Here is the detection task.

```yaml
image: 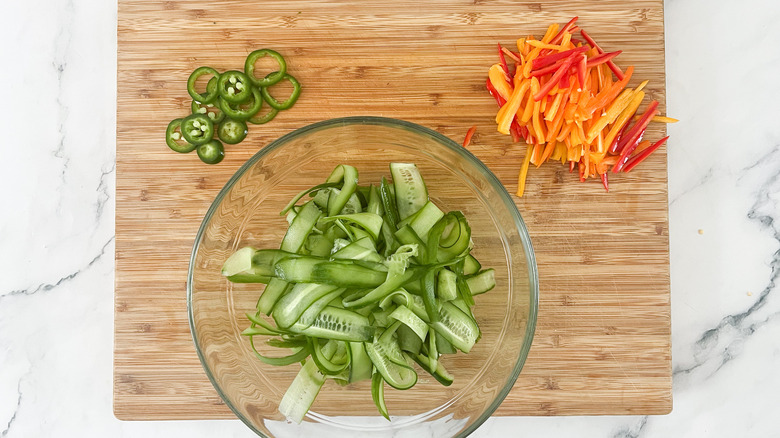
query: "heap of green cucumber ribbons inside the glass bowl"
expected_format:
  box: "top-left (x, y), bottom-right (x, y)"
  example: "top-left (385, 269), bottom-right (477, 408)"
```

top-left (225, 163), bottom-right (495, 422)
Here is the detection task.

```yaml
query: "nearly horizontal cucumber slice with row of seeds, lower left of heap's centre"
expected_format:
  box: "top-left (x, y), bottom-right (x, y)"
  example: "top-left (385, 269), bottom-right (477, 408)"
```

top-left (290, 306), bottom-right (375, 342)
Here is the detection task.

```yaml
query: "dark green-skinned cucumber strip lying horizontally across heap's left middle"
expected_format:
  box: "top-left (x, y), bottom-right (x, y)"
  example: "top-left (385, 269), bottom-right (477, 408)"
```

top-left (276, 257), bottom-right (387, 288)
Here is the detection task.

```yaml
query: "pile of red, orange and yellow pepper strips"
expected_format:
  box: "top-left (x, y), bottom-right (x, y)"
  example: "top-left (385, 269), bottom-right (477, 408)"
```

top-left (487, 17), bottom-right (677, 196)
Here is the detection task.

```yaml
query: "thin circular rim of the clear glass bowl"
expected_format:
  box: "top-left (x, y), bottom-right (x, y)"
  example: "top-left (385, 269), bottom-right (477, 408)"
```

top-left (187, 116), bottom-right (539, 438)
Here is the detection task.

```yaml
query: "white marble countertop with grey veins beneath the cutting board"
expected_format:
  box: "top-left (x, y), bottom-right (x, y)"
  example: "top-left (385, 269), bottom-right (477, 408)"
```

top-left (0, 0), bottom-right (780, 438)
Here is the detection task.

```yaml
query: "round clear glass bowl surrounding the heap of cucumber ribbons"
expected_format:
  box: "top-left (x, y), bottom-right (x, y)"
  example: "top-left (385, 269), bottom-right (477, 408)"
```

top-left (187, 117), bottom-right (538, 438)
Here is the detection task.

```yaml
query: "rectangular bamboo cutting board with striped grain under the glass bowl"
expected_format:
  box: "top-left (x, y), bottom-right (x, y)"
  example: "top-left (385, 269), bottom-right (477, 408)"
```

top-left (114, 0), bottom-right (674, 420)
